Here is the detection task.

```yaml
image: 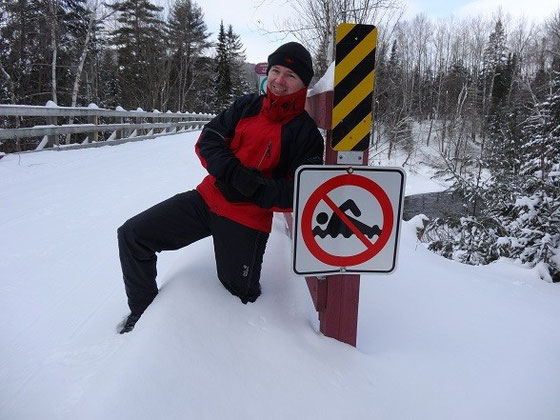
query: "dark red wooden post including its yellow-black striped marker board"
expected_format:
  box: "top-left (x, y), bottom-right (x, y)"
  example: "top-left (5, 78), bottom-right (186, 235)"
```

top-left (288, 24), bottom-right (377, 346)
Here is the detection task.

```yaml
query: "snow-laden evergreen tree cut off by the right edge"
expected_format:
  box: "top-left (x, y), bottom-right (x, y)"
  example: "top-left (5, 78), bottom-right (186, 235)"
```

top-left (505, 72), bottom-right (560, 281)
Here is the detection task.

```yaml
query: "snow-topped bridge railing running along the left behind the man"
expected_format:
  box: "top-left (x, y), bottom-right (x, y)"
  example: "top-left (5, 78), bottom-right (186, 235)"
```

top-left (0, 103), bottom-right (214, 152)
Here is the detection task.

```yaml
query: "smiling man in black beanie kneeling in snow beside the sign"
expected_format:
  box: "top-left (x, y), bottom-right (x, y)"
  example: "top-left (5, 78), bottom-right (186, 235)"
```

top-left (118, 42), bottom-right (323, 334)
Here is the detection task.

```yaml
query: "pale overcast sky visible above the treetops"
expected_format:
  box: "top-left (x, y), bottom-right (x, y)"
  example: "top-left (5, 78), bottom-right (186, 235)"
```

top-left (160, 0), bottom-right (560, 63)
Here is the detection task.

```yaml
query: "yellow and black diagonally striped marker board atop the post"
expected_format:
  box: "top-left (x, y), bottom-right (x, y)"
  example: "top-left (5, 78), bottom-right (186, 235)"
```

top-left (332, 23), bottom-right (377, 151)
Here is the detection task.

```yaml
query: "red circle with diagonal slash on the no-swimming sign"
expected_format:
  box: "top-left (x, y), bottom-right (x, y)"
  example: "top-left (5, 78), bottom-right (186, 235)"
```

top-left (301, 174), bottom-right (394, 267)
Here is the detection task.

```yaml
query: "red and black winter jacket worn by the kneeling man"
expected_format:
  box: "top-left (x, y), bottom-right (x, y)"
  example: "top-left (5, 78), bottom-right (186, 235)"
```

top-left (195, 89), bottom-right (323, 232)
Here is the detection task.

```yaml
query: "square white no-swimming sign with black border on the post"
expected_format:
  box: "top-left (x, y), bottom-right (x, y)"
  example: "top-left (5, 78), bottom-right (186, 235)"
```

top-left (293, 165), bottom-right (405, 275)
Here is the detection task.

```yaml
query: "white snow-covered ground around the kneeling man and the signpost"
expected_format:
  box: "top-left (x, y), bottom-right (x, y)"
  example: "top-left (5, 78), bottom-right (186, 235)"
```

top-left (0, 133), bottom-right (560, 420)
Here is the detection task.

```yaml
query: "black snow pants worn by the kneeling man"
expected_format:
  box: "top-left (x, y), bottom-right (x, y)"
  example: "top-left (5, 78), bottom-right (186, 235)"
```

top-left (117, 190), bottom-right (268, 315)
